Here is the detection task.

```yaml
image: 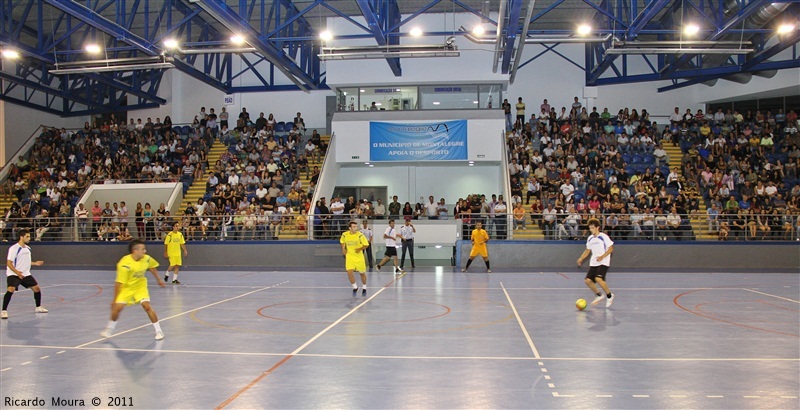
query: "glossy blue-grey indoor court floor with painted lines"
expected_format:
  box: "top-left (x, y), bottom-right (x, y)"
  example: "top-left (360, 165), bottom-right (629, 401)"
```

top-left (0, 263), bottom-right (800, 409)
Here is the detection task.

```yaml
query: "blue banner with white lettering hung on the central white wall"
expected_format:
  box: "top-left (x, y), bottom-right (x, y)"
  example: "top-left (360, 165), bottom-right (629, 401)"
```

top-left (369, 120), bottom-right (467, 161)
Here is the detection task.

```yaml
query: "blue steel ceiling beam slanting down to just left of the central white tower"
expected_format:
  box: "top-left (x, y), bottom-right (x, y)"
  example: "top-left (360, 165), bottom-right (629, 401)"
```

top-left (195, 0), bottom-right (319, 91)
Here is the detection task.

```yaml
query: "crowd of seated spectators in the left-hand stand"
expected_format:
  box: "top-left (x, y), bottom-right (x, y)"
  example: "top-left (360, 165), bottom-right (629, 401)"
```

top-left (0, 107), bottom-right (326, 240)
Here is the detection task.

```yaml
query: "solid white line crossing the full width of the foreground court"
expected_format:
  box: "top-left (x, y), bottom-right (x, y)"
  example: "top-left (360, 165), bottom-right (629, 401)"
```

top-left (0, 344), bottom-right (800, 360)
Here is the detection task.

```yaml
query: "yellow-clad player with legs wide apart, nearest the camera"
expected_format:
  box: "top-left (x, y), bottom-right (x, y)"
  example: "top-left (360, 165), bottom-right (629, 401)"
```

top-left (100, 239), bottom-right (167, 340)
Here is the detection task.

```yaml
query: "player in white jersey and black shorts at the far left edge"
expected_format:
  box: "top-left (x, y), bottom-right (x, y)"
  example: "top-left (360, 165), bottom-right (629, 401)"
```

top-left (0, 229), bottom-right (47, 319)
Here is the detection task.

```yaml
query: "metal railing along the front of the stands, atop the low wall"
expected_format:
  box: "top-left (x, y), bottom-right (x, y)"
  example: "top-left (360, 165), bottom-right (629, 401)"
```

top-left (0, 208), bottom-right (800, 242)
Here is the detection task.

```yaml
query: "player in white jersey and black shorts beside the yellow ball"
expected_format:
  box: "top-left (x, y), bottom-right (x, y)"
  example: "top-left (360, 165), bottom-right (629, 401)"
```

top-left (578, 218), bottom-right (614, 307)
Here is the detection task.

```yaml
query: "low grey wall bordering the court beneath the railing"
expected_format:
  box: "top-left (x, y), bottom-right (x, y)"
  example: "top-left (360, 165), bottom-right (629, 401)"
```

top-left (28, 241), bottom-right (800, 273)
